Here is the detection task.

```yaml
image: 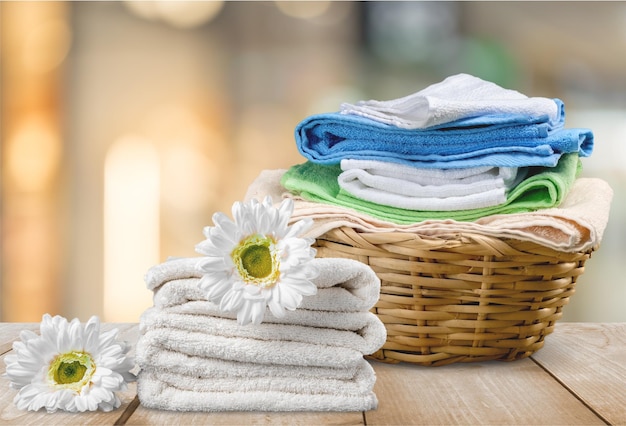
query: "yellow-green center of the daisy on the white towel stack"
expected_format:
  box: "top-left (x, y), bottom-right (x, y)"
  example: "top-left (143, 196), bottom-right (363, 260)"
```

top-left (231, 234), bottom-right (280, 288)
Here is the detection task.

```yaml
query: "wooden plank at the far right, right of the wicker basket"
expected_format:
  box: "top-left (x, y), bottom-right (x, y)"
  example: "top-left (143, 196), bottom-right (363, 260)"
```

top-left (532, 323), bottom-right (626, 425)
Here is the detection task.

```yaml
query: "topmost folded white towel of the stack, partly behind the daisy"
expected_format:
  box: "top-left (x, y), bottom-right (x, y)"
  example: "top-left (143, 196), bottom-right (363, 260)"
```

top-left (145, 258), bottom-right (380, 312)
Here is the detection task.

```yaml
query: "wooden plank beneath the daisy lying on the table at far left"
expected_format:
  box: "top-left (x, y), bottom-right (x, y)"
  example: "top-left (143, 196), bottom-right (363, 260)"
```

top-left (0, 323), bottom-right (138, 425)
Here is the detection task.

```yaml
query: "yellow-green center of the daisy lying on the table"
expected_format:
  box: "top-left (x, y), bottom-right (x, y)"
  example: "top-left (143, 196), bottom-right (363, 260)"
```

top-left (48, 352), bottom-right (96, 392)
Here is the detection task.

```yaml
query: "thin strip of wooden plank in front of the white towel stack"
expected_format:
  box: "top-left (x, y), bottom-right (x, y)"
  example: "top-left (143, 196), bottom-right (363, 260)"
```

top-left (126, 406), bottom-right (364, 426)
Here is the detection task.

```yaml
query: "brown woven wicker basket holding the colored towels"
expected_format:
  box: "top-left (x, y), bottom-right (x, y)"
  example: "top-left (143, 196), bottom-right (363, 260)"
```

top-left (314, 227), bottom-right (593, 366)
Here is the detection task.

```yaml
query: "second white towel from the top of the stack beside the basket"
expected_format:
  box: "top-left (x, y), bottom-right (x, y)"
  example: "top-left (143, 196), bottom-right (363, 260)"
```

top-left (139, 308), bottom-right (386, 355)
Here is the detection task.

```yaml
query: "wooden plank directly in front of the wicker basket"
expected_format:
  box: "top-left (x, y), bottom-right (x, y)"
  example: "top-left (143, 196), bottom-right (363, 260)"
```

top-left (365, 359), bottom-right (604, 425)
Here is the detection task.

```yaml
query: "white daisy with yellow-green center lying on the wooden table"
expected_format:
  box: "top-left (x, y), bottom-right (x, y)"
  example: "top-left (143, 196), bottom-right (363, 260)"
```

top-left (4, 314), bottom-right (135, 413)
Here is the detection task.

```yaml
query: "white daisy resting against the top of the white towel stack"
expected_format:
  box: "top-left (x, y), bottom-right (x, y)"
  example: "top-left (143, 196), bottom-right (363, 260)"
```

top-left (196, 197), bottom-right (317, 325)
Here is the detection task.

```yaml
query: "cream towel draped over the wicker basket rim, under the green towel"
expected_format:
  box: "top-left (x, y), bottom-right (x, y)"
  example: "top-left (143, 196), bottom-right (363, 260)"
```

top-left (245, 169), bottom-right (613, 253)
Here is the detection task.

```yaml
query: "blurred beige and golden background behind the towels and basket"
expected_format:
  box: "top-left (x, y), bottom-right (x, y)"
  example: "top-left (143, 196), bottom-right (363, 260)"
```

top-left (0, 1), bottom-right (626, 322)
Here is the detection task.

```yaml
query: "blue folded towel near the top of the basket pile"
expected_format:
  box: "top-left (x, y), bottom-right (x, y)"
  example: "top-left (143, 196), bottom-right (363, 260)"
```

top-left (295, 113), bottom-right (593, 169)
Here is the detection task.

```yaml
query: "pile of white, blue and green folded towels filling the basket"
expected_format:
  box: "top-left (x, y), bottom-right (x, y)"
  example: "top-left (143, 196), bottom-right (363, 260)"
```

top-left (282, 74), bottom-right (593, 224)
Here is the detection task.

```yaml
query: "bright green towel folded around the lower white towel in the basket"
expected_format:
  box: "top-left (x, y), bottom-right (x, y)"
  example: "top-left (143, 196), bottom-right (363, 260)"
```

top-left (281, 153), bottom-right (582, 224)
